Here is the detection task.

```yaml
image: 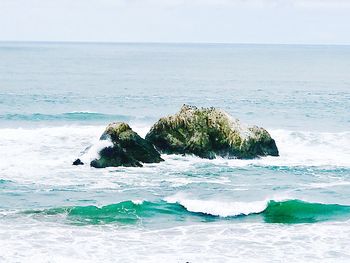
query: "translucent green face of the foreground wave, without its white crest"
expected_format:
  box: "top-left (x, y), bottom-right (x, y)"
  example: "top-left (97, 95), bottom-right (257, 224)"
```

top-left (24, 200), bottom-right (350, 225)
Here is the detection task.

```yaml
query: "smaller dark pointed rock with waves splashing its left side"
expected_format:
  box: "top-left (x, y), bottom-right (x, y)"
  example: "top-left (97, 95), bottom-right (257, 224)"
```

top-left (90, 122), bottom-right (163, 168)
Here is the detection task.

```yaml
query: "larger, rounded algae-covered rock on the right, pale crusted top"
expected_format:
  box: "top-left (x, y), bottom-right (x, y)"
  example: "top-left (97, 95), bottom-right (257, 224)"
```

top-left (146, 105), bottom-right (278, 159)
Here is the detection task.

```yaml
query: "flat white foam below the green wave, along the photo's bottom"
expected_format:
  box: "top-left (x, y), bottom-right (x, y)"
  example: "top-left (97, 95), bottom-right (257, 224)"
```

top-left (0, 218), bottom-right (350, 263)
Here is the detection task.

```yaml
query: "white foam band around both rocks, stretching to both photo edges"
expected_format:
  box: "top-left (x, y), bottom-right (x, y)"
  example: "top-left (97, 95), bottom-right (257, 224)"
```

top-left (0, 124), bottom-right (350, 188)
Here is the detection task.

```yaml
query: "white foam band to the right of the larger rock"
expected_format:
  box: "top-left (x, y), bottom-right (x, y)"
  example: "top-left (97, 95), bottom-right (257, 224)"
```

top-left (202, 130), bottom-right (350, 167)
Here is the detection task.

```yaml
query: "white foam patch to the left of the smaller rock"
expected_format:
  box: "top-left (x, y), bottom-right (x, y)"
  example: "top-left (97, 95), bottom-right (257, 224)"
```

top-left (0, 126), bottom-right (104, 184)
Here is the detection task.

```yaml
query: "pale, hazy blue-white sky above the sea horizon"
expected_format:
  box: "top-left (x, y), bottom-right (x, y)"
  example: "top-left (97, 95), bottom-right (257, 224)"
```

top-left (0, 0), bottom-right (350, 44)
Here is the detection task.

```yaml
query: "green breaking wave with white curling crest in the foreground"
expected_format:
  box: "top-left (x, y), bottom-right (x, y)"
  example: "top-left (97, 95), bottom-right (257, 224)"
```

top-left (22, 199), bottom-right (350, 225)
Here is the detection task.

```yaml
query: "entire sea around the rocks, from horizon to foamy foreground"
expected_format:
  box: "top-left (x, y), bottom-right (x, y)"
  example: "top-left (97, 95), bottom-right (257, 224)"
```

top-left (0, 42), bottom-right (350, 262)
